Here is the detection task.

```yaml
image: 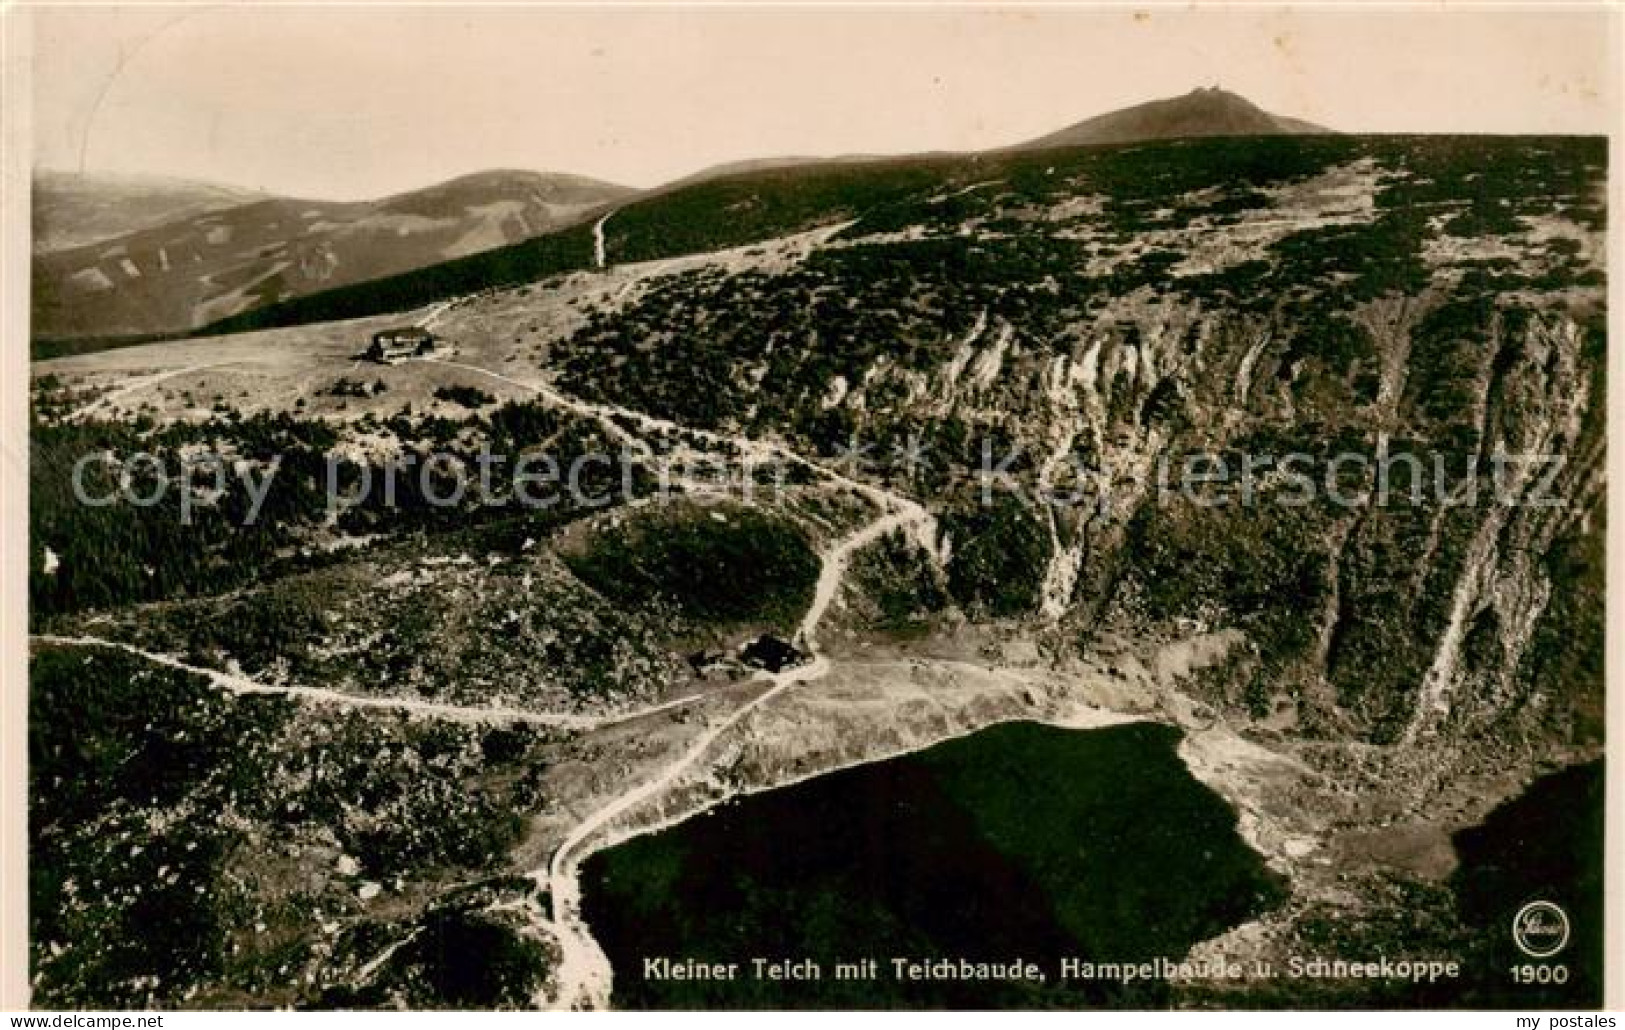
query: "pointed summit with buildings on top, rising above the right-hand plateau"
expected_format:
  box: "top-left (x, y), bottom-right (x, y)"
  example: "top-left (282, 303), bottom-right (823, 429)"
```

top-left (1011, 88), bottom-right (1331, 149)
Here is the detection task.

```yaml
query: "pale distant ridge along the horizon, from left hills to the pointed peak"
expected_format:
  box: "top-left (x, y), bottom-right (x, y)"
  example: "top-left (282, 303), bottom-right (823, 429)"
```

top-left (34, 88), bottom-right (1329, 341)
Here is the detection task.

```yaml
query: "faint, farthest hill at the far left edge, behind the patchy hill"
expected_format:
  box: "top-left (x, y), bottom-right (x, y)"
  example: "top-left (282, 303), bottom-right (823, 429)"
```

top-left (33, 169), bottom-right (260, 253)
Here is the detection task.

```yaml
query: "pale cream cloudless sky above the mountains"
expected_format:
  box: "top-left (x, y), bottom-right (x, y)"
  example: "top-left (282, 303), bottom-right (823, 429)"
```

top-left (28, 3), bottom-right (1619, 200)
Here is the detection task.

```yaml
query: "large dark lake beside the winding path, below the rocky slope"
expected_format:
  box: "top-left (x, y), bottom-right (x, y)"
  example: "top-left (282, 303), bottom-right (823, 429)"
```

top-left (582, 723), bottom-right (1282, 1009)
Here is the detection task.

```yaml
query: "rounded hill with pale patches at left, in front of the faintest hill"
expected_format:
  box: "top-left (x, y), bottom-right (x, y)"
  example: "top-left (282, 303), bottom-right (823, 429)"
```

top-left (34, 171), bottom-right (632, 340)
